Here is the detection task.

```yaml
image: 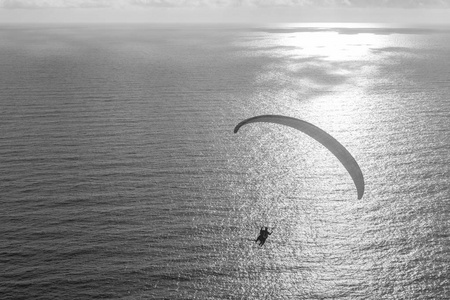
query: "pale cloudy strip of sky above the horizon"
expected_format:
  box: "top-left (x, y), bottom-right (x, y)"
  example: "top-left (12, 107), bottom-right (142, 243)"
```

top-left (0, 0), bottom-right (450, 24)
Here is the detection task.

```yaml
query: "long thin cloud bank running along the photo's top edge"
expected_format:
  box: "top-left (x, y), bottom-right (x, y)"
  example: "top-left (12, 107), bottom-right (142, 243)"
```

top-left (0, 0), bottom-right (450, 9)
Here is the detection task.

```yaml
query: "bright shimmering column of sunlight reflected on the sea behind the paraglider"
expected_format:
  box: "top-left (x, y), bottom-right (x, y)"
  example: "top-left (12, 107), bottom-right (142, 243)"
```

top-left (232, 26), bottom-right (436, 298)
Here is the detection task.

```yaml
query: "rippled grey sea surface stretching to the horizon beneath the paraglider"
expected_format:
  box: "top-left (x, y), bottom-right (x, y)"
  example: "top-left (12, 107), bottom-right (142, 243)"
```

top-left (0, 24), bottom-right (450, 300)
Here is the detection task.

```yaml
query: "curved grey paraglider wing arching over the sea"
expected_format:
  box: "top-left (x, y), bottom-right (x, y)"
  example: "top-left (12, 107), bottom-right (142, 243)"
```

top-left (234, 115), bottom-right (364, 199)
